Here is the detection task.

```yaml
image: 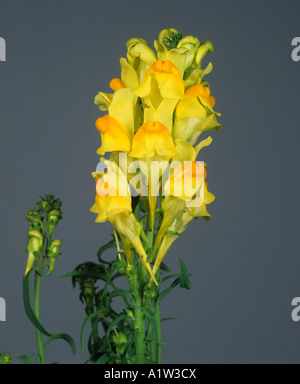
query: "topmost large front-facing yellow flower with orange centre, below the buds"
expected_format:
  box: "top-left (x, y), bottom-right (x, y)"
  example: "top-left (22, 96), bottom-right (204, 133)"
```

top-left (134, 60), bottom-right (184, 132)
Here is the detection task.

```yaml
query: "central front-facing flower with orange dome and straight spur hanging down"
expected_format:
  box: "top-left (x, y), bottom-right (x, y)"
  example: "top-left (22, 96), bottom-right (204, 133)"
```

top-left (129, 121), bottom-right (177, 228)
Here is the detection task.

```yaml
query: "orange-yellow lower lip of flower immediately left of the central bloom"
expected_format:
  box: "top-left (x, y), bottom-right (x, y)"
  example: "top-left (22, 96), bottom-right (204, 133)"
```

top-left (96, 116), bottom-right (131, 155)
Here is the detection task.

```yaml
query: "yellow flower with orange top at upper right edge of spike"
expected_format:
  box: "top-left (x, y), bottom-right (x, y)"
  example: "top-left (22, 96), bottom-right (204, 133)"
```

top-left (172, 84), bottom-right (222, 145)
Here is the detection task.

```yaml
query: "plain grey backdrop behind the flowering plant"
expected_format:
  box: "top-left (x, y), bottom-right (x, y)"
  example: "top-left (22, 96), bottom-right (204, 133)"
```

top-left (0, 0), bottom-right (300, 364)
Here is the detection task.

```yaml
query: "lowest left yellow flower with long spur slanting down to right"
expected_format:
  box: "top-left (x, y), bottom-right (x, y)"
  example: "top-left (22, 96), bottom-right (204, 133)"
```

top-left (91, 160), bottom-right (156, 282)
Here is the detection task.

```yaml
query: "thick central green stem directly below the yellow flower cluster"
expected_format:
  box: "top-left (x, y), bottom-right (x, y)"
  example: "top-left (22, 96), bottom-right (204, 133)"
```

top-left (134, 261), bottom-right (146, 364)
